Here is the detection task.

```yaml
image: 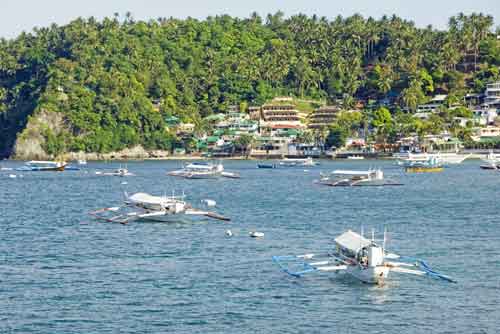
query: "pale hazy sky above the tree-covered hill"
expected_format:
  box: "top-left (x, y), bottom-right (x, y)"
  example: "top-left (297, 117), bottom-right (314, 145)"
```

top-left (0, 0), bottom-right (500, 38)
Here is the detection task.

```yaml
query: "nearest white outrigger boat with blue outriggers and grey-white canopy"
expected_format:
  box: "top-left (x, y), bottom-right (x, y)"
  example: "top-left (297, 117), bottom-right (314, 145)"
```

top-left (273, 230), bottom-right (456, 284)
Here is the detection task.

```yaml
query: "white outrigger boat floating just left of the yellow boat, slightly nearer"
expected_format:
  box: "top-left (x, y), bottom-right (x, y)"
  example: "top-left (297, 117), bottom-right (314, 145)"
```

top-left (319, 169), bottom-right (388, 187)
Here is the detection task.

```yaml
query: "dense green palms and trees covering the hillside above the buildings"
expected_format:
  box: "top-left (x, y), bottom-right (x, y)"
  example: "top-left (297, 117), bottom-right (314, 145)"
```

top-left (0, 12), bottom-right (500, 153)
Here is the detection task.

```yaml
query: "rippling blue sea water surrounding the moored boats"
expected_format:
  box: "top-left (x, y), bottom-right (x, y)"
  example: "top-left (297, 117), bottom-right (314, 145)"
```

top-left (0, 161), bottom-right (500, 334)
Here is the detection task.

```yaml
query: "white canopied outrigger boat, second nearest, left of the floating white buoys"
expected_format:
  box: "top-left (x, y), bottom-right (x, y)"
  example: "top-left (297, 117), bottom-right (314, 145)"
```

top-left (89, 193), bottom-right (230, 224)
